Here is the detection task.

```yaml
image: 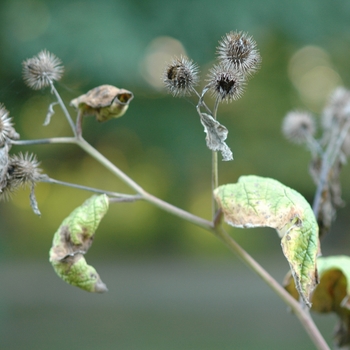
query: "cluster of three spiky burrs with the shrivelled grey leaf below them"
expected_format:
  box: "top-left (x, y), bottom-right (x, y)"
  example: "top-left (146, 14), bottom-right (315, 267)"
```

top-left (163, 32), bottom-right (261, 160)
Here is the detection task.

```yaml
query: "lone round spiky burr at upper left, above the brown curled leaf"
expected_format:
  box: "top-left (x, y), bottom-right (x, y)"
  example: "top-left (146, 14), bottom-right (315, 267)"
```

top-left (22, 50), bottom-right (64, 90)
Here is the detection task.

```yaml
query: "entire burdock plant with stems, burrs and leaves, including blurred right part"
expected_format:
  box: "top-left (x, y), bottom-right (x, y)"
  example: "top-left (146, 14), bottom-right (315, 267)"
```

top-left (0, 32), bottom-right (350, 349)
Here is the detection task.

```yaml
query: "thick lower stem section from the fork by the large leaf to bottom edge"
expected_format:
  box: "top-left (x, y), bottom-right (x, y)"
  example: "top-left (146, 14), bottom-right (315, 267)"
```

top-left (213, 227), bottom-right (330, 350)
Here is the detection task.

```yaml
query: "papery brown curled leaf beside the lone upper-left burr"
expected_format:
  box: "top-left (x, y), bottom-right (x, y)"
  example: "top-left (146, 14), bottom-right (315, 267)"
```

top-left (70, 85), bottom-right (134, 122)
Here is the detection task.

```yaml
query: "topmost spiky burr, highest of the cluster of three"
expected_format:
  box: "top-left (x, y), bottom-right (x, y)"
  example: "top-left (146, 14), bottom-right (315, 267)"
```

top-left (216, 32), bottom-right (261, 76)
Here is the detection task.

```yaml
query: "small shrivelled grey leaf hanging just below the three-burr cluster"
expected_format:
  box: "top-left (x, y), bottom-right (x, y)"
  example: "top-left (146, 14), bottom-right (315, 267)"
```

top-left (199, 113), bottom-right (233, 160)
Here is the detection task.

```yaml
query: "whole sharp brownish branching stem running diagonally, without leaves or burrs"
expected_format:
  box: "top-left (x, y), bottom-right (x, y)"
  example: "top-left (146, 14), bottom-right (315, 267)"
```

top-left (12, 84), bottom-right (328, 350)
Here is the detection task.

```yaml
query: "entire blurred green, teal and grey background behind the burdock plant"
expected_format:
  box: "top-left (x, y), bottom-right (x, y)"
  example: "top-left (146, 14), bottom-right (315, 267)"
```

top-left (0, 0), bottom-right (350, 350)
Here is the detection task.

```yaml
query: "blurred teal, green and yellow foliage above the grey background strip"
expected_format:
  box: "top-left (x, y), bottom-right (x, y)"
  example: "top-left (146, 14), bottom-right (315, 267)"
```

top-left (0, 0), bottom-right (350, 256)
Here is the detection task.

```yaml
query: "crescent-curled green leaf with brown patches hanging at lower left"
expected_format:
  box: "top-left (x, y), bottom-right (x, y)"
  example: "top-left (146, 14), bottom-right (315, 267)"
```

top-left (50, 194), bottom-right (109, 293)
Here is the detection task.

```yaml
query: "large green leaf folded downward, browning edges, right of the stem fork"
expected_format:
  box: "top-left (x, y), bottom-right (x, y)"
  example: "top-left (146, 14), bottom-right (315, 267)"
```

top-left (214, 175), bottom-right (319, 307)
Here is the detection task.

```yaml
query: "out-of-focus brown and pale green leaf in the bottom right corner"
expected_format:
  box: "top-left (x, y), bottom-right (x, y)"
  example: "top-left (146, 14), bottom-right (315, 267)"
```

top-left (283, 255), bottom-right (350, 349)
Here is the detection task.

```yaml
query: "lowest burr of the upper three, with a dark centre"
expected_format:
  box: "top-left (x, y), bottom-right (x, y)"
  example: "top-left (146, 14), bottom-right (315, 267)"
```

top-left (207, 64), bottom-right (245, 102)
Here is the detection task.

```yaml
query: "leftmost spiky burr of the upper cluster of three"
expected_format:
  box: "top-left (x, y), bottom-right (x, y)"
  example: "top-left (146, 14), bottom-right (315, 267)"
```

top-left (163, 56), bottom-right (199, 96)
